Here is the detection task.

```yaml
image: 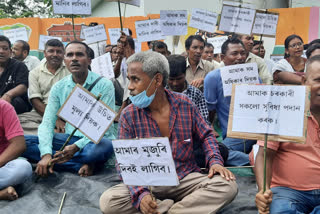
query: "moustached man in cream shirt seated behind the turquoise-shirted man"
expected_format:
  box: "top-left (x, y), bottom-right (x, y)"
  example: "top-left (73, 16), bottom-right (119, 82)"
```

top-left (19, 39), bottom-right (70, 135)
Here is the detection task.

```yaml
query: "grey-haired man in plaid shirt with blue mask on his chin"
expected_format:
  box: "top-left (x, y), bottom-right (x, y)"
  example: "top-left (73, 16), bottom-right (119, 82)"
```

top-left (100, 52), bottom-right (237, 214)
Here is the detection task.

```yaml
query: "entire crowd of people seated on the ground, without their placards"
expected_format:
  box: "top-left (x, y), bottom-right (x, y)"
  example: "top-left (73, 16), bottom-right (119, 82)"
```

top-left (0, 33), bottom-right (320, 213)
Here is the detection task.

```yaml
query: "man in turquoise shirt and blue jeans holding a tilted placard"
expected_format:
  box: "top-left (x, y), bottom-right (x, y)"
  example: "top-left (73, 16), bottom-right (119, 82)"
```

top-left (23, 41), bottom-right (115, 176)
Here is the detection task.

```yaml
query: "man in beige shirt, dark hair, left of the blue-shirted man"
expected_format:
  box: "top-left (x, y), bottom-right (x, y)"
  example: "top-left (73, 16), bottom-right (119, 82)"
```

top-left (185, 35), bottom-right (216, 89)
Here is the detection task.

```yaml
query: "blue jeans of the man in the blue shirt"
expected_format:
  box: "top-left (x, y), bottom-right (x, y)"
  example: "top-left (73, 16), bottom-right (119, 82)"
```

top-left (222, 137), bottom-right (257, 166)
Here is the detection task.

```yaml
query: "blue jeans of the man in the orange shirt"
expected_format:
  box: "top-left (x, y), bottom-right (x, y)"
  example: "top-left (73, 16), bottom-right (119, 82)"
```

top-left (270, 187), bottom-right (320, 214)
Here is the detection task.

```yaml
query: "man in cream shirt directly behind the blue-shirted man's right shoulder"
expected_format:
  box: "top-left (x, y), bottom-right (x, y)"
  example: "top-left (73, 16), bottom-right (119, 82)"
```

top-left (232, 34), bottom-right (272, 85)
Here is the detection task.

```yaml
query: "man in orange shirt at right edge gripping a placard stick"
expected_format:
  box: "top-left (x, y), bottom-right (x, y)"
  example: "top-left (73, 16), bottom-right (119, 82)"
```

top-left (255, 55), bottom-right (320, 214)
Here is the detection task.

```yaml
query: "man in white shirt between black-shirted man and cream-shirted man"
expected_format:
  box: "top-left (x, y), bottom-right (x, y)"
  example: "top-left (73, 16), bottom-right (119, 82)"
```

top-left (12, 40), bottom-right (40, 71)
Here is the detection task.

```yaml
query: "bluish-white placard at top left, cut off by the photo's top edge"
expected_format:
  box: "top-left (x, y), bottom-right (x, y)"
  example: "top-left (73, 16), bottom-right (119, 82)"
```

top-left (52, 0), bottom-right (91, 15)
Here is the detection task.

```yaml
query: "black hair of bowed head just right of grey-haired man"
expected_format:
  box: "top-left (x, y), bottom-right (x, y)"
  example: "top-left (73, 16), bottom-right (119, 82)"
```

top-left (167, 54), bottom-right (187, 77)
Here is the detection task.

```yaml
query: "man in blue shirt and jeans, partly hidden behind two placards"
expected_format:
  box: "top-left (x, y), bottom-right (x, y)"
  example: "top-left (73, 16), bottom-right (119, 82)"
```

top-left (204, 38), bottom-right (255, 166)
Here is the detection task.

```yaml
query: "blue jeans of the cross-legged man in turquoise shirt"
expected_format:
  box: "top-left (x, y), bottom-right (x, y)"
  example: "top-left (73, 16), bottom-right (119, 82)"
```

top-left (22, 133), bottom-right (113, 172)
